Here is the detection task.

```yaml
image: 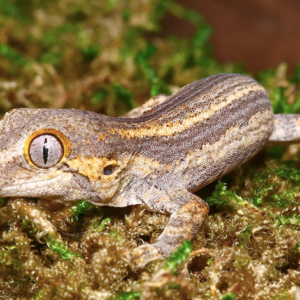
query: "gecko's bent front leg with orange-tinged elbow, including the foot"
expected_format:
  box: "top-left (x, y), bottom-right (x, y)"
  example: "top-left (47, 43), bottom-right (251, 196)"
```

top-left (131, 189), bottom-right (209, 269)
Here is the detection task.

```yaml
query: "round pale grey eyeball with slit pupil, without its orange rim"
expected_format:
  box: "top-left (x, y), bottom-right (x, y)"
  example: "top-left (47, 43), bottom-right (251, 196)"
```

top-left (29, 134), bottom-right (64, 169)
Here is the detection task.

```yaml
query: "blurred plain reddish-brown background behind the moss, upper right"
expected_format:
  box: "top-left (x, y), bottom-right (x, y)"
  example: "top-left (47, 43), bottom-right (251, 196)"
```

top-left (162, 0), bottom-right (300, 73)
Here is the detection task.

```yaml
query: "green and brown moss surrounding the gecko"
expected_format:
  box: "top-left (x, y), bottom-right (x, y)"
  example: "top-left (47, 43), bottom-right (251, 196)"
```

top-left (0, 0), bottom-right (300, 300)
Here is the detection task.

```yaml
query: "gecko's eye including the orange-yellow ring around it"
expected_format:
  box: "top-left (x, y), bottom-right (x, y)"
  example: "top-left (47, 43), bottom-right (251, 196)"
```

top-left (24, 129), bottom-right (71, 169)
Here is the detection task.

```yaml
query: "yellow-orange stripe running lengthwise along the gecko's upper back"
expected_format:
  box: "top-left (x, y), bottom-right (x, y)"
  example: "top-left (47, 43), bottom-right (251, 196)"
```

top-left (108, 77), bottom-right (265, 140)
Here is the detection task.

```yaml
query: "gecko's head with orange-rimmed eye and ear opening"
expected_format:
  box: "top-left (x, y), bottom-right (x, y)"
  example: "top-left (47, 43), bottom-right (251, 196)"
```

top-left (0, 109), bottom-right (130, 205)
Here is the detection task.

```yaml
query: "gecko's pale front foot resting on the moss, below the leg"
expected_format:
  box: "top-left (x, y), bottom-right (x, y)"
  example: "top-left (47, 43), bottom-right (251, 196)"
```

top-left (130, 244), bottom-right (162, 270)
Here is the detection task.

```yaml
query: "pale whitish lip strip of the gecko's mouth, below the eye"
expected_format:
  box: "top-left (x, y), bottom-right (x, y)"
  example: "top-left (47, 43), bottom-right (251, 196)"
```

top-left (0, 173), bottom-right (72, 197)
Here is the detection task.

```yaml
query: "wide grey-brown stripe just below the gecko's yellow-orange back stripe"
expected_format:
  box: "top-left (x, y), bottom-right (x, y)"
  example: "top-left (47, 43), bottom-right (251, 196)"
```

top-left (135, 88), bottom-right (271, 164)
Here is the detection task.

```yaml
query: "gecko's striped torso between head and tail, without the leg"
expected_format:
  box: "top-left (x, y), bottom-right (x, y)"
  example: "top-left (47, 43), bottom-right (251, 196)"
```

top-left (116, 74), bottom-right (274, 191)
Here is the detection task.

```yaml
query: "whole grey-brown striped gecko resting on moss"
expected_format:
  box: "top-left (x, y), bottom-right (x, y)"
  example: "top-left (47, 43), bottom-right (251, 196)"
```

top-left (0, 74), bottom-right (300, 269)
